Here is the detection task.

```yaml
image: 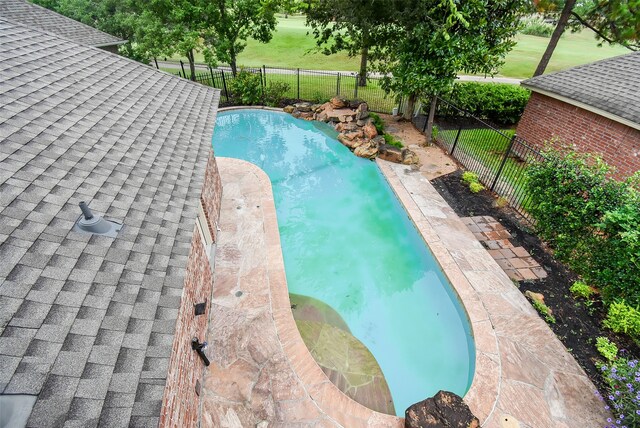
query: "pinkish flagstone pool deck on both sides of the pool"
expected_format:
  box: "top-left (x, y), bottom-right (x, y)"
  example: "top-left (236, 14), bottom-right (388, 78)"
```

top-left (200, 158), bottom-right (607, 428)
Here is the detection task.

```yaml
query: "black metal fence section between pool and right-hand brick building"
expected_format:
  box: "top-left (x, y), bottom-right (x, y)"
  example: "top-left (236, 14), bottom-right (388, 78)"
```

top-left (414, 98), bottom-right (543, 221)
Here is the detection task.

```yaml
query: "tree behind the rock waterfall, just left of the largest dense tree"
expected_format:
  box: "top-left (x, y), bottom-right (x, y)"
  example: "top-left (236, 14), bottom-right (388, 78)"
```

top-left (307, 0), bottom-right (391, 86)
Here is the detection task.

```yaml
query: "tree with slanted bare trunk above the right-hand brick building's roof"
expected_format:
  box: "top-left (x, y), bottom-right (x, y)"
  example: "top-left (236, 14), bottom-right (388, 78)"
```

top-left (533, 0), bottom-right (640, 76)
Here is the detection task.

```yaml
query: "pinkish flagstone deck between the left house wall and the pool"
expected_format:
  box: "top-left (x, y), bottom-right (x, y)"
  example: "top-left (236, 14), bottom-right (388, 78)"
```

top-left (201, 158), bottom-right (404, 428)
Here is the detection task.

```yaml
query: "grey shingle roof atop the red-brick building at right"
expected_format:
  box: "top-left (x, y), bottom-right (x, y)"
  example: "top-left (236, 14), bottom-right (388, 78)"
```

top-left (522, 52), bottom-right (640, 124)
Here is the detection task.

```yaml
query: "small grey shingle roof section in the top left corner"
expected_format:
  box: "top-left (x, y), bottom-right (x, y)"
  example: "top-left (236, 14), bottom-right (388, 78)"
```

top-left (0, 0), bottom-right (124, 47)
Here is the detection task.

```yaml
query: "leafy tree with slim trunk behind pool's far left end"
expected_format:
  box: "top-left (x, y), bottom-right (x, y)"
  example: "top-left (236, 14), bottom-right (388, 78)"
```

top-left (203, 0), bottom-right (278, 76)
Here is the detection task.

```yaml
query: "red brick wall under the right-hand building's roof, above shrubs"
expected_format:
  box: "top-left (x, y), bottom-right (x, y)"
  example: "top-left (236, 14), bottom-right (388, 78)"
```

top-left (517, 92), bottom-right (640, 179)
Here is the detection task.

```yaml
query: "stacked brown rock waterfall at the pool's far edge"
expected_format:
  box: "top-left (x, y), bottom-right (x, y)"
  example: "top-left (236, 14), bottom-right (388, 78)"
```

top-left (284, 97), bottom-right (418, 165)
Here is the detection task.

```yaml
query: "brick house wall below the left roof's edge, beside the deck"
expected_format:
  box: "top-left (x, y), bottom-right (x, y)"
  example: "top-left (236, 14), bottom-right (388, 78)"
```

top-left (159, 153), bottom-right (222, 427)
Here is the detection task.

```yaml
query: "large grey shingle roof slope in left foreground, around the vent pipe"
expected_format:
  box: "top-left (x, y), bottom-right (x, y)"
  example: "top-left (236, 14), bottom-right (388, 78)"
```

top-left (0, 18), bottom-right (218, 427)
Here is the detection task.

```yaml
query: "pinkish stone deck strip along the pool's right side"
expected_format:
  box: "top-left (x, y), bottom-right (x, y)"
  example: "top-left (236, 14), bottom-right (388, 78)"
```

top-left (376, 159), bottom-right (609, 428)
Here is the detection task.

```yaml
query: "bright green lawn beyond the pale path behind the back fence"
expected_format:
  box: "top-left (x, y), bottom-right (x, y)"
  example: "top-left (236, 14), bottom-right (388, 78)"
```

top-left (175, 16), bottom-right (629, 78)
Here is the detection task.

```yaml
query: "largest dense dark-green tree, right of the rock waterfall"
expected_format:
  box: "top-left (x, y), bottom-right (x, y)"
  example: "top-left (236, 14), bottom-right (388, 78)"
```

top-left (377, 0), bottom-right (526, 120)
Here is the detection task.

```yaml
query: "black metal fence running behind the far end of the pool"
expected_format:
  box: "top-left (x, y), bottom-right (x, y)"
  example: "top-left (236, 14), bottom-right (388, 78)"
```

top-left (165, 61), bottom-right (398, 113)
